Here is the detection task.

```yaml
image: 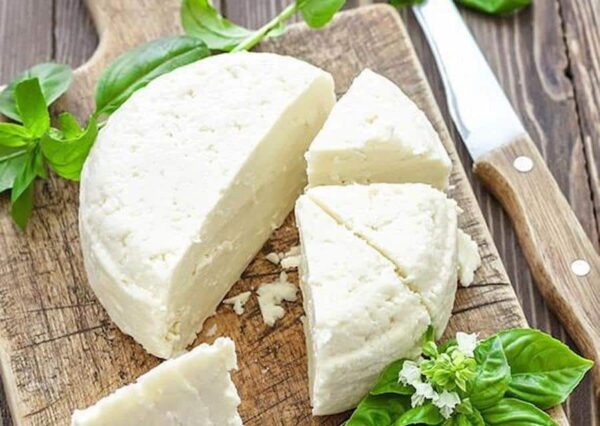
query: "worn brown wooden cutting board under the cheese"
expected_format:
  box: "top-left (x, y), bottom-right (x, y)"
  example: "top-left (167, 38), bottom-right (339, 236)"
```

top-left (0, 0), bottom-right (567, 425)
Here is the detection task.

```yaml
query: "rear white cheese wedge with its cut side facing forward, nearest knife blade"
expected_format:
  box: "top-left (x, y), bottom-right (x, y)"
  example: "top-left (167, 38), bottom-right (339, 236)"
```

top-left (306, 69), bottom-right (451, 189)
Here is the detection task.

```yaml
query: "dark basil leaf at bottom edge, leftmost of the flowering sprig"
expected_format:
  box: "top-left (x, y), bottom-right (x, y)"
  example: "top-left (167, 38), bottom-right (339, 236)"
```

top-left (345, 395), bottom-right (410, 426)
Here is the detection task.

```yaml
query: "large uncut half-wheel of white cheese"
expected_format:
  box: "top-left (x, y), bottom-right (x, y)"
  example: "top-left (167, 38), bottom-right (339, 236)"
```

top-left (79, 52), bottom-right (335, 358)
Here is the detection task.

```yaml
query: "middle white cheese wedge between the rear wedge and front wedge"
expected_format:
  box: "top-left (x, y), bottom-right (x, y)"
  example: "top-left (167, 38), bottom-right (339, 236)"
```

top-left (307, 184), bottom-right (458, 337)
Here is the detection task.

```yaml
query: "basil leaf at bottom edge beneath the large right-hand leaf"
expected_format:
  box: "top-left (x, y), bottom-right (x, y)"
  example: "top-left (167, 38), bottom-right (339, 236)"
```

top-left (481, 398), bottom-right (556, 426)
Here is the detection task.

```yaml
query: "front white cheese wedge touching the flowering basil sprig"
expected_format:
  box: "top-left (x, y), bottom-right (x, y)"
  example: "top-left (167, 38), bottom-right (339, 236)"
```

top-left (295, 195), bottom-right (430, 415)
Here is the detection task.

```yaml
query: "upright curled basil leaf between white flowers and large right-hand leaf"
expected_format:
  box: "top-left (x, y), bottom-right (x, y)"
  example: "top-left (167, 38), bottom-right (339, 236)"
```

top-left (469, 337), bottom-right (511, 409)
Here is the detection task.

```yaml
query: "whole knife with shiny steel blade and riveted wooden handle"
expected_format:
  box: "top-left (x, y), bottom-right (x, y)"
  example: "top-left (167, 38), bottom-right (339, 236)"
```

top-left (413, 0), bottom-right (600, 400)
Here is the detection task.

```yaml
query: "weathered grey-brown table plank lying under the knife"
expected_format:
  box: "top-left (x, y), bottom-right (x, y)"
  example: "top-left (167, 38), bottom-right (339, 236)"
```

top-left (396, 2), bottom-right (598, 424)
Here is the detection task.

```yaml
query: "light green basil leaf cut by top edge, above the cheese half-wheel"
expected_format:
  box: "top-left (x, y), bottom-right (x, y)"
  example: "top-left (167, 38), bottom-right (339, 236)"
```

top-left (181, 0), bottom-right (253, 51)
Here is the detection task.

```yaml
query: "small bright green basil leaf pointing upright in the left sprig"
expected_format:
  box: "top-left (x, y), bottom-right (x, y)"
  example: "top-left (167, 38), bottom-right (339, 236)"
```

top-left (15, 78), bottom-right (50, 138)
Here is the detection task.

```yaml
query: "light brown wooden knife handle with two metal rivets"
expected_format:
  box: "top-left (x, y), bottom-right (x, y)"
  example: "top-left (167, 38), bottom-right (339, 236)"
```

top-left (475, 136), bottom-right (600, 400)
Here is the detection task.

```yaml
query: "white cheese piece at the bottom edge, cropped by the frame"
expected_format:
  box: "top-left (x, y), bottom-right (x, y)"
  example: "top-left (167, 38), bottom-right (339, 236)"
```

top-left (71, 338), bottom-right (242, 426)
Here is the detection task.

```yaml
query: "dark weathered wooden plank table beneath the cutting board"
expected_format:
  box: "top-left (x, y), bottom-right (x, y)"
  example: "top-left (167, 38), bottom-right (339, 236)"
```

top-left (0, 0), bottom-right (600, 425)
